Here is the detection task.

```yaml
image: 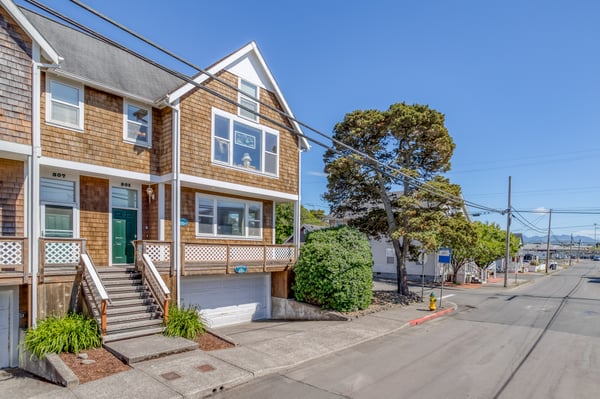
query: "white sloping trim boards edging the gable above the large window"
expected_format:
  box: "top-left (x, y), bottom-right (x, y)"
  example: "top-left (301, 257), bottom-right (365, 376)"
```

top-left (167, 42), bottom-right (310, 150)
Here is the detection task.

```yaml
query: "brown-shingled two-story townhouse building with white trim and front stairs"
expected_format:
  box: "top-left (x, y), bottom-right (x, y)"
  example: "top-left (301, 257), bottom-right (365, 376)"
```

top-left (0, 0), bottom-right (308, 368)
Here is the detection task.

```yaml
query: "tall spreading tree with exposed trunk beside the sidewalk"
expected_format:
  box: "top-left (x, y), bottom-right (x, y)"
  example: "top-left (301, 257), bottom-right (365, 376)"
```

top-left (323, 103), bottom-right (454, 295)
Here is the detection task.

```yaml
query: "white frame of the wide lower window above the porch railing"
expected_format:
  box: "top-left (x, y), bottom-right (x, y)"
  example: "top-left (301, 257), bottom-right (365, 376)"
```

top-left (195, 193), bottom-right (264, 240)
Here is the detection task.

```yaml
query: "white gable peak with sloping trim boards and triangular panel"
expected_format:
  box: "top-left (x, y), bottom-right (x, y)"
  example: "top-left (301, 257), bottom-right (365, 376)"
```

top-left (167, 41), bottom-right (310, 149)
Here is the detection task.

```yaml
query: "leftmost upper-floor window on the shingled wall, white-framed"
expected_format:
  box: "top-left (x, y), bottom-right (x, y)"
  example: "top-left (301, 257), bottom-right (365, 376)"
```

top-left (46, 78), bottom-right (83, 130)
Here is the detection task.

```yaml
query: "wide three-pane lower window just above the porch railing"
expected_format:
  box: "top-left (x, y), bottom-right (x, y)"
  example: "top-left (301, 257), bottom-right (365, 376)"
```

top-left (196, 194), bottom-right (262, 238)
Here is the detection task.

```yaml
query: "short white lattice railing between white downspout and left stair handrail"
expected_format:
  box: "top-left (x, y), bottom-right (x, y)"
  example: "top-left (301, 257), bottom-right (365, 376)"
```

top-left (40, 238), bottom-right (85, 276)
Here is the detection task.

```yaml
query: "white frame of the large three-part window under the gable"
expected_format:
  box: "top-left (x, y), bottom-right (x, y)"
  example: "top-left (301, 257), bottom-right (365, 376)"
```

top-left (210, 108), bottom-right (281, 177)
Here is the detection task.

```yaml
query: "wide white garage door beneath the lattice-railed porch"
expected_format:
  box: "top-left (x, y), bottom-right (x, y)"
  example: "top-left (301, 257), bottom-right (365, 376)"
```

top-left (181, 273), bottom-right (271, 327)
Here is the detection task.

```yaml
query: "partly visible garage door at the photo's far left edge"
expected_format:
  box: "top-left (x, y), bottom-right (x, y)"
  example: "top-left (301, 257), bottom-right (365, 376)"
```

top-left (0, 289), bottom-right (19, 368)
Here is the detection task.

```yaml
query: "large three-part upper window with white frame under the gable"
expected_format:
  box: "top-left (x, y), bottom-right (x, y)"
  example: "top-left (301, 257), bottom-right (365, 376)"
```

top-left (212, 109), bottom-right (279, 176)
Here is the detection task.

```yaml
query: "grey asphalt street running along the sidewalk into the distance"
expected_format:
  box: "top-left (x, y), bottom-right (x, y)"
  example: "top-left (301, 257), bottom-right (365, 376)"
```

top-left (215, 261), bottom-right (600, 399)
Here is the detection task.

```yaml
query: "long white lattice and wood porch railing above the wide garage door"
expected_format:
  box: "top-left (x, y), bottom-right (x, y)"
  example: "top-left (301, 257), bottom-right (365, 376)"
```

top-left (182, 243), bottom-right (297, 274)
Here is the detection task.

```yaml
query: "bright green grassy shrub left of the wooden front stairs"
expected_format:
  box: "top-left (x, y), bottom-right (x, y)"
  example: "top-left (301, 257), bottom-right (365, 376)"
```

top-left (24, 313), bottom-right (102, 359)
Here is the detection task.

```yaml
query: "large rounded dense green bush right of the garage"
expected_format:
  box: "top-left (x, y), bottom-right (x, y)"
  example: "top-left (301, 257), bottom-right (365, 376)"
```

top-left (293, 226), bottom-right (373, 312)
